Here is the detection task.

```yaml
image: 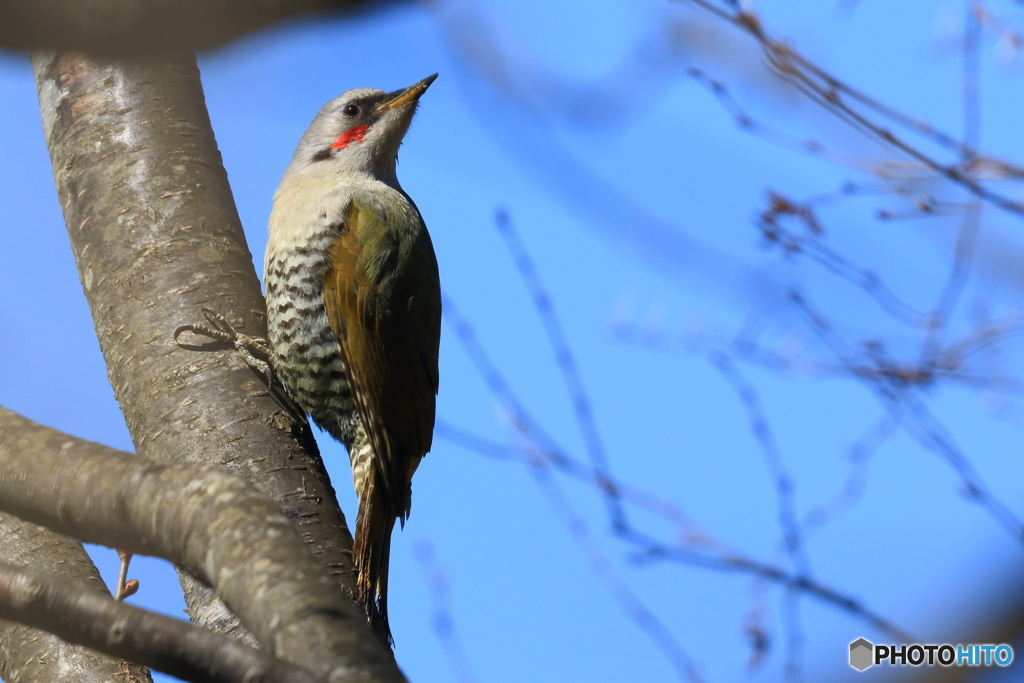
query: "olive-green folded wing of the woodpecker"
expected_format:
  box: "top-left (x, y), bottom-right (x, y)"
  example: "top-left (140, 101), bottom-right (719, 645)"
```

top-left (324, 198), bottom-right (440, 511)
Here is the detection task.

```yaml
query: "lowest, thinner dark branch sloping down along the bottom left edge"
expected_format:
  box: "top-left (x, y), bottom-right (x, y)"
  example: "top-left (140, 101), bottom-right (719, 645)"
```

top-left (0, 562), bottom-right (324, 683)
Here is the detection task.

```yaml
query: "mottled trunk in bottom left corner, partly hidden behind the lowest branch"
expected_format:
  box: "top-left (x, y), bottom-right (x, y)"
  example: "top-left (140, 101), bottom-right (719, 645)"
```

top-left (0, 513), bottom-right (152, 683)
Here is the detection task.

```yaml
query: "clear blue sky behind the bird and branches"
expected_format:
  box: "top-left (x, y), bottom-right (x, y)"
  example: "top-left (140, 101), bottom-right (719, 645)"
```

top-left (0, 0), bottom-right (1024, 683)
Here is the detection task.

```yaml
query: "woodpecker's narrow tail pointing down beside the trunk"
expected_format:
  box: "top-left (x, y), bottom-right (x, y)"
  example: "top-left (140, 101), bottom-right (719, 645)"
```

top-left (351, 430), bottom-right (398, 646)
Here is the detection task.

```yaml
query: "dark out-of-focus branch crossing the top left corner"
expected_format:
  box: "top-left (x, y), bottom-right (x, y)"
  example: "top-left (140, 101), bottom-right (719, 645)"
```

top-left (0, 0), bottom-right (398, 55)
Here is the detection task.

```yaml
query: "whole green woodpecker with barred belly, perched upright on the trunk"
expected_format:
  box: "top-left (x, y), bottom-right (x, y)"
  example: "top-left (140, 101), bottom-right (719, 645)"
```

top-left (264, 74), bottom-right (441, 643)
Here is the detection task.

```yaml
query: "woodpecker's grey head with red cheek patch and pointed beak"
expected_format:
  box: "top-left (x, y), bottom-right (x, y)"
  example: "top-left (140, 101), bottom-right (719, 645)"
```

top-left (291, 74), bottom-right (437, 185)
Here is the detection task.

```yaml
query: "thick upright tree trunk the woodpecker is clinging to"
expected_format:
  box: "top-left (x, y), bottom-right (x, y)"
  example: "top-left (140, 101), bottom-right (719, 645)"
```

top-left (33, 53), bottom-right (354, 638)
